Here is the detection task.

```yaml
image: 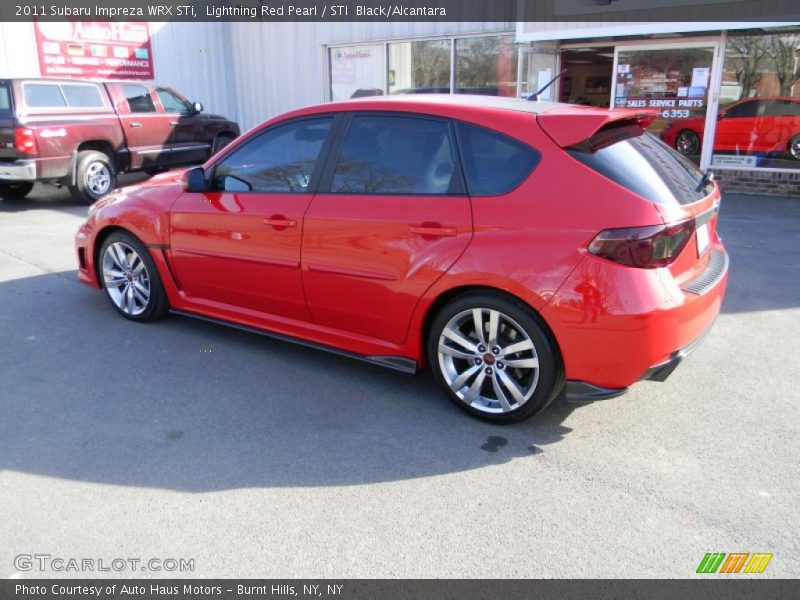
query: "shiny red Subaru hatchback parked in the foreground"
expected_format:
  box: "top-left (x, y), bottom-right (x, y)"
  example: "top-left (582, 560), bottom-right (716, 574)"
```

top-left (76, 95), bottom-right (728, 421)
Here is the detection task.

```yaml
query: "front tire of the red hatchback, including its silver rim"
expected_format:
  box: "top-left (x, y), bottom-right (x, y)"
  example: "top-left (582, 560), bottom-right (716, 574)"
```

top-left (97, 231), bottom-right (169, 321)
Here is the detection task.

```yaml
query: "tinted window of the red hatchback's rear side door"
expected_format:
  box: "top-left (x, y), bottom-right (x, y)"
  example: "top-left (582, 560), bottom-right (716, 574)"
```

top-left (331, 115), bottom-right (463, 195)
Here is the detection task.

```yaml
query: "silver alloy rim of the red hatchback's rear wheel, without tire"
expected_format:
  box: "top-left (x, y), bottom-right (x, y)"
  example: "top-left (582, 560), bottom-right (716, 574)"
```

top-left (438, 308), bottom-right (539, 414)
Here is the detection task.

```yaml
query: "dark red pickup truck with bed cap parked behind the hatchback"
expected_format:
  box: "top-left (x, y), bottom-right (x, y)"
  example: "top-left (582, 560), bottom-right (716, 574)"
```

top-left (0, 79), bottom-right (239, 203)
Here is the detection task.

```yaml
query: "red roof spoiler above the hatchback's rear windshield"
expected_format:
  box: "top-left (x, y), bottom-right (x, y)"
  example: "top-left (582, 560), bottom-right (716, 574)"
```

top-left (536, 106), bottom-right (658, 148)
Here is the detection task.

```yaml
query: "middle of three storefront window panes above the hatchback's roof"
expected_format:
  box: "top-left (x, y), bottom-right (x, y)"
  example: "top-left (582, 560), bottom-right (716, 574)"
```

top-left (388, 40), bottom-right (450, 94)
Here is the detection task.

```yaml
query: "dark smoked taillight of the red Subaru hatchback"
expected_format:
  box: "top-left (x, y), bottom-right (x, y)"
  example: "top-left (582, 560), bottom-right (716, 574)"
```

top-left (589, 219), bottom-right (694, 269)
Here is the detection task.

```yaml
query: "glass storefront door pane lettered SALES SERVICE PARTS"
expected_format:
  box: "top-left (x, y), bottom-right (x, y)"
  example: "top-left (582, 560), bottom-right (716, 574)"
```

top-left (611, 46), bottom-right (714, 164)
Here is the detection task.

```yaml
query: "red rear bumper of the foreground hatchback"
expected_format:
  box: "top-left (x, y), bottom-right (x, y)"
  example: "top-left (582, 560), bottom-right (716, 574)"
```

top-left (541, 242), bottom-right (728, 392)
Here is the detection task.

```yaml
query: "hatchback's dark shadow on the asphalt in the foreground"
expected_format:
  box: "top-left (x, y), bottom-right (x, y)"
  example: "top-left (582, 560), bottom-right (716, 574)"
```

top-left (0, 273), bottom-right (575, 492)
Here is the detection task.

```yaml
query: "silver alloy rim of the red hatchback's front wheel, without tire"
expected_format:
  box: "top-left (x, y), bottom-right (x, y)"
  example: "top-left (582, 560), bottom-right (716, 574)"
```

top-left (103, 242), bottom-right (151, 316)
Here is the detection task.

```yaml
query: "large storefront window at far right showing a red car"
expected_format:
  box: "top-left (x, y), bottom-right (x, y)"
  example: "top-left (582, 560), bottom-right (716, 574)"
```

top-left (711, 33), bottom-right (800, 169)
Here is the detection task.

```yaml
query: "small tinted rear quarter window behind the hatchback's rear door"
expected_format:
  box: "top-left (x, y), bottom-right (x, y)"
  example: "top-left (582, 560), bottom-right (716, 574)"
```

top-left (456, 122), bottom-right (540, 196)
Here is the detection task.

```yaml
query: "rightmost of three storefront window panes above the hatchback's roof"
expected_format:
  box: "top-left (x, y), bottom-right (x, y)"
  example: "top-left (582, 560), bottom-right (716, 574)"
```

top-left (454, 35), bottom-right (519, 97)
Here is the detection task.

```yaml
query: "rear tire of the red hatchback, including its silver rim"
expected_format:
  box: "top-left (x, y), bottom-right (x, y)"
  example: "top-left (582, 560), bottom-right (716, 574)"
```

top-left (426, 292), bottom-right (564, 423)
